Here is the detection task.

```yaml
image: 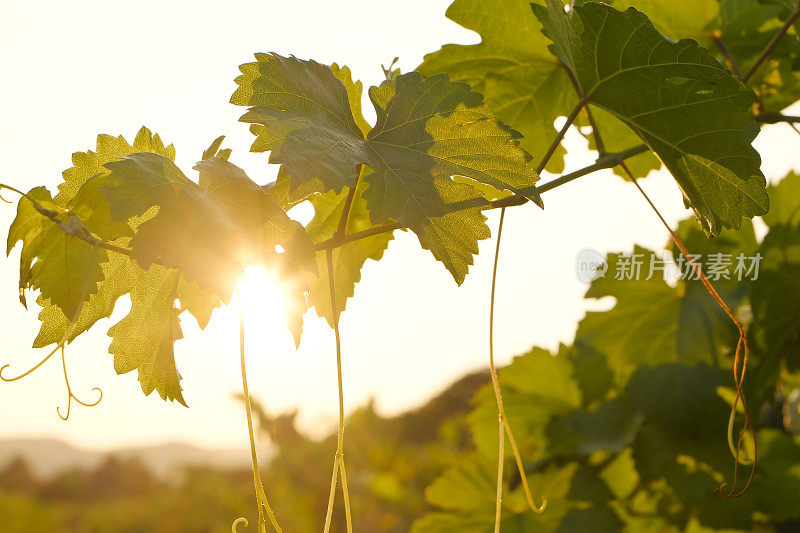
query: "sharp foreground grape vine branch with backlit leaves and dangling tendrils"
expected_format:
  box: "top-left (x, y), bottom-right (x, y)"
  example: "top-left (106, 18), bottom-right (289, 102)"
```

top-left (0, 0), bottom-right (800, 533)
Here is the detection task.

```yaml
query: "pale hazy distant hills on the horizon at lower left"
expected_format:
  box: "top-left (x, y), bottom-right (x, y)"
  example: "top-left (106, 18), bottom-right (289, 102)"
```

top-left (0, 438), bottom-right (255, 479)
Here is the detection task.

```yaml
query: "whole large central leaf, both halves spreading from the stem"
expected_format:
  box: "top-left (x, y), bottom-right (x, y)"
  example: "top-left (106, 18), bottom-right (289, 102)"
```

top-left (231, 54), bottom-right (540, 283)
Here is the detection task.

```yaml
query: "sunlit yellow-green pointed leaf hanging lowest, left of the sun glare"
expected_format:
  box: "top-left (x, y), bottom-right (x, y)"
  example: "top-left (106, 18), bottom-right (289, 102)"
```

top-left (108, 265), bottom-right (186, 406)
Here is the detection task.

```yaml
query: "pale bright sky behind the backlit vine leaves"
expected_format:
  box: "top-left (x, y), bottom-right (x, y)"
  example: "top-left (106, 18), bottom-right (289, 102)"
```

top-left (0, 0), bottom-right (800, 448)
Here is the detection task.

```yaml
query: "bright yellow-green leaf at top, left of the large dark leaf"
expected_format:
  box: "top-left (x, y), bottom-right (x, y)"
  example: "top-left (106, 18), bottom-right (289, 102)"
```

top-left (418, 0), bottom-right (576, 172)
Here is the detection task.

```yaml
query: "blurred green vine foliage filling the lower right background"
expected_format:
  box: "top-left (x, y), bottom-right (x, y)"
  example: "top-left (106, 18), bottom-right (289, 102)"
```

top-left (413, 174), bottom-right (800, 533)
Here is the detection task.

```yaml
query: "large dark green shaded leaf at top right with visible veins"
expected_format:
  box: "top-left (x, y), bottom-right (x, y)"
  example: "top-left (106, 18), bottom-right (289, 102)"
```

top-left (533, 0), bottom-right (769, 235)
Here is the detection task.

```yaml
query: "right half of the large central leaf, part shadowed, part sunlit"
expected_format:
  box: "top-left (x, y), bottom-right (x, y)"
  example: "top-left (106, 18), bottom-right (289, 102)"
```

top-left (364, 72), bottom-right (541, 284)
